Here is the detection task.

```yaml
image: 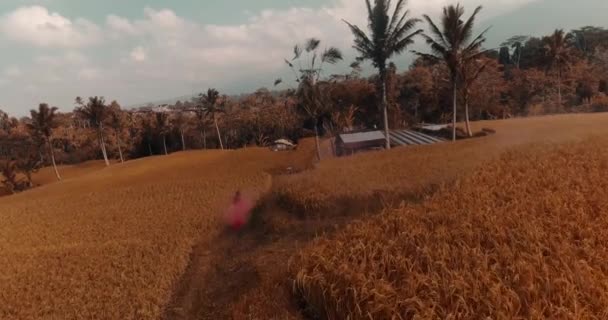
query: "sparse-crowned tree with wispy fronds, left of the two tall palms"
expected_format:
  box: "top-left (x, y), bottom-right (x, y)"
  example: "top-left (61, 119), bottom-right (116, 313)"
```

top-left (275, 38), bottom-right (343, 160)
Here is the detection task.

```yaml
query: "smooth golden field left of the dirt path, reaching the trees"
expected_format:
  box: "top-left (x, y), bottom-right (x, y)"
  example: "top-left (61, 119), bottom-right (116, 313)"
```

top-left (0, 142), bottom-right (320, 319)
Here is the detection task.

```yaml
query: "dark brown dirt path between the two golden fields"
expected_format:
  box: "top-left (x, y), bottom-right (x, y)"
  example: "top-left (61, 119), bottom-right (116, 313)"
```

top-left (163, 201), bottom-right (346, 320)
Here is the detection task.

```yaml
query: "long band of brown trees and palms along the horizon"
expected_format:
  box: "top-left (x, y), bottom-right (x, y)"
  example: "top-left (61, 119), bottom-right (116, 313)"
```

top-left (0, 0), bottom-right (608, 192)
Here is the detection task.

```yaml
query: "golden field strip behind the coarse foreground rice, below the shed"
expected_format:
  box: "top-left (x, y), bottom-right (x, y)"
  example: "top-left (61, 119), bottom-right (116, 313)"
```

top-left (276, 114), bottom-right (608, 215)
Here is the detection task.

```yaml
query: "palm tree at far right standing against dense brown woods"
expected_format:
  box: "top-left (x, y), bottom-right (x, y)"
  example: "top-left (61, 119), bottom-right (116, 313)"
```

top-left (543, 30), bottom-right (572, 107)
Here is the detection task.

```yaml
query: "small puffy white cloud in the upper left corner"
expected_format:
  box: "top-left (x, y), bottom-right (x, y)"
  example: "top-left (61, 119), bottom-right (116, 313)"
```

top-left (0, 6), bottom-right (101, 48)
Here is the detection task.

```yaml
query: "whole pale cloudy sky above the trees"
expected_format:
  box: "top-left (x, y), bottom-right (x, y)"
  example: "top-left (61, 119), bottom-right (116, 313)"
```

top-left (0, 0), bottom-right (608, 116)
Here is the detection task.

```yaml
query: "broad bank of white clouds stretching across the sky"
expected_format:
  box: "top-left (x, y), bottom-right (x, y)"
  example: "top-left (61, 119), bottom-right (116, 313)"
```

top-left (0, 0), bottom-right (535, 114)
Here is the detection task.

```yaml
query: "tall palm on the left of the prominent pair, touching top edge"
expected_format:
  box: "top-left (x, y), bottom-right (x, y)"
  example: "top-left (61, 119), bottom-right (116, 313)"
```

top-left (345, 0), bottom-right (422, 149)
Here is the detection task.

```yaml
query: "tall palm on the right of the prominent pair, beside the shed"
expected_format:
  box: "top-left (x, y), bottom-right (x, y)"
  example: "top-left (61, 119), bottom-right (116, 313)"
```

top-left (416, 4), bottom-right (488, 141)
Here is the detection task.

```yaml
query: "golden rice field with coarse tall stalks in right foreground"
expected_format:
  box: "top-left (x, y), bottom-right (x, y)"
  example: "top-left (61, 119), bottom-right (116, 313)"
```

top-left (292, 137), bottom-right (608, 319)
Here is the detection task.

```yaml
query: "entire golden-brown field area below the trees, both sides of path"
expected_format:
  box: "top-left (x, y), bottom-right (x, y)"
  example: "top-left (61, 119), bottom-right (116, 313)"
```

top-left (0, 114), bottom-right (608, 319)
